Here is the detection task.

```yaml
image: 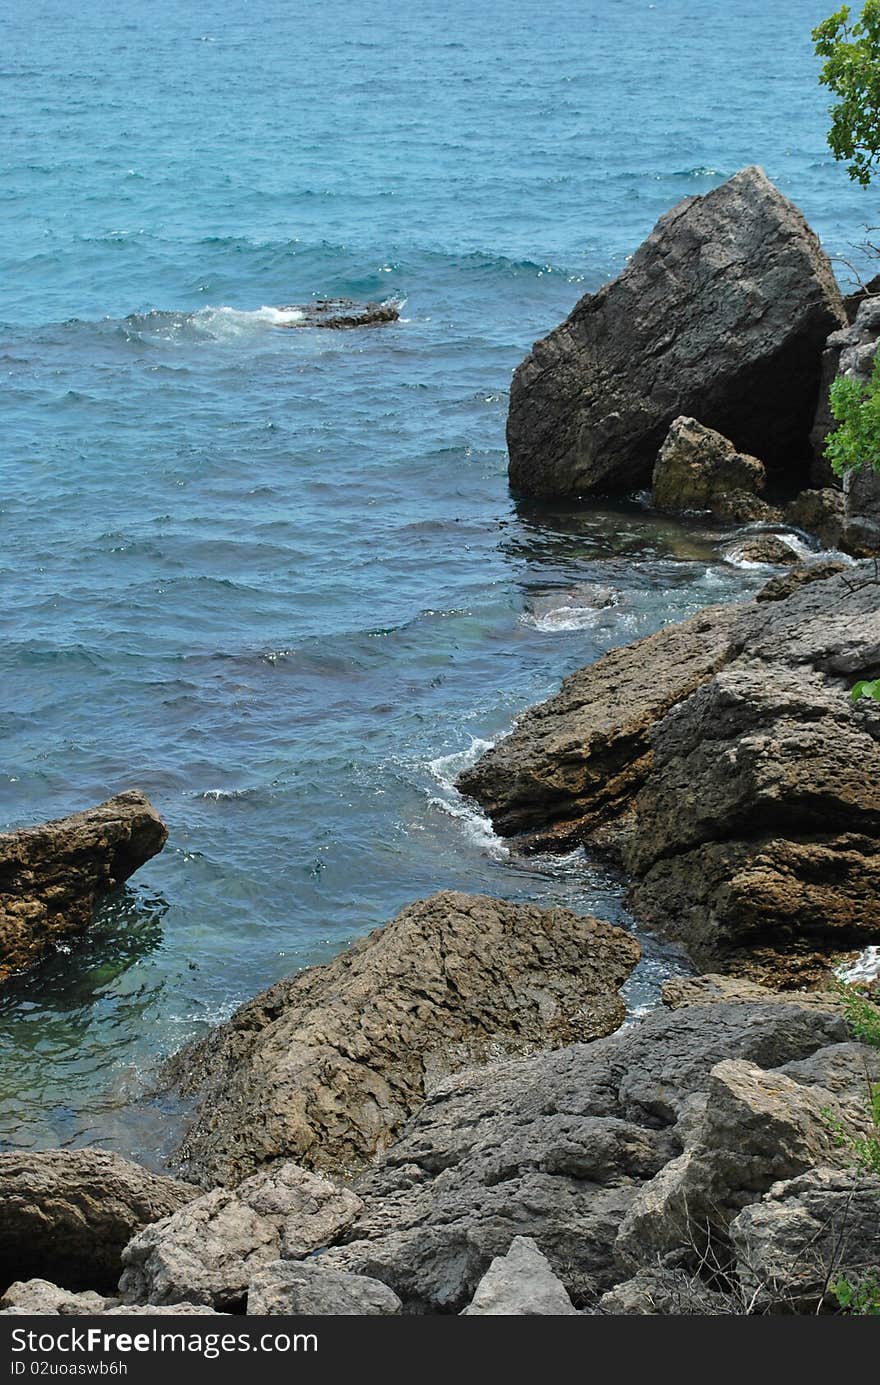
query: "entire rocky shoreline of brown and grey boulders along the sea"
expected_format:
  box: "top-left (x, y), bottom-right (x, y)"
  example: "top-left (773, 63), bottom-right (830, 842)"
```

top-left (0, 169), bottom-right (880, 1316)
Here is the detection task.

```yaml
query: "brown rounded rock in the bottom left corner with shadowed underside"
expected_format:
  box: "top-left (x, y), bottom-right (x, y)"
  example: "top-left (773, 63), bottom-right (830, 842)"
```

top-left (0, 1150), bottom-right (197, 1292)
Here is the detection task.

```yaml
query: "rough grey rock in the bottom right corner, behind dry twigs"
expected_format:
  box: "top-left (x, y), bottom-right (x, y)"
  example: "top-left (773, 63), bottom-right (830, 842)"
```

top-left (730, 1168), bottom-right (880, 1313)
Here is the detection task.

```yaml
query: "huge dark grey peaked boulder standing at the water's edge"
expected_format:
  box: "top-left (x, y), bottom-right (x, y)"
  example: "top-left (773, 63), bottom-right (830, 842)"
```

top-left (507, 168), bottom-right (845, 496)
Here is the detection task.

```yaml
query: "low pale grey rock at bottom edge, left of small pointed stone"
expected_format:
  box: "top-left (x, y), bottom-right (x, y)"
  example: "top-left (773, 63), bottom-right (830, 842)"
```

top-left (248, 1260), bottom-right (401, 1317)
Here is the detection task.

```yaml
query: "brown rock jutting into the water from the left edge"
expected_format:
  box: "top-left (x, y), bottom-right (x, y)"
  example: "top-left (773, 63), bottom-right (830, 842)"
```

top-left (0, 791), bottom-right (168, 982)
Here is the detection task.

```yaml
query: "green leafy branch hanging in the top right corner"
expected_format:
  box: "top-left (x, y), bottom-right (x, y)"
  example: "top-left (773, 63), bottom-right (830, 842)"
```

top-left (812, 0), bottom-right (880, 187)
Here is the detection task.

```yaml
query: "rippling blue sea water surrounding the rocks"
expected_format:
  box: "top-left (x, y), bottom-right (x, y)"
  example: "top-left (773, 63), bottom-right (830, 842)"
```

top-left (0, 0), bottom-right (876, 1162)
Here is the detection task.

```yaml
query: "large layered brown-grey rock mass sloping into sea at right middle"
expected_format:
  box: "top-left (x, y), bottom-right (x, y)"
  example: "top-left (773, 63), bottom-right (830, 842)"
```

top-left (459, 564), bottom-right (880, 986)
